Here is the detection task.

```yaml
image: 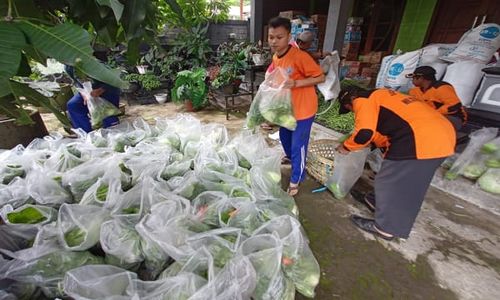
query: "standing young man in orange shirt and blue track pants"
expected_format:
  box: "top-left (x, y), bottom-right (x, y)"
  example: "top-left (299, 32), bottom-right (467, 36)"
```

top-left (268, 17), bottom-right (325, 196)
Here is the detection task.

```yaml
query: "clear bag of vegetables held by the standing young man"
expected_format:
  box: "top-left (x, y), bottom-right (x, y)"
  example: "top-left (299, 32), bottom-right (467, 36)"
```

top-left (247, 67), bottom-right (297, 130)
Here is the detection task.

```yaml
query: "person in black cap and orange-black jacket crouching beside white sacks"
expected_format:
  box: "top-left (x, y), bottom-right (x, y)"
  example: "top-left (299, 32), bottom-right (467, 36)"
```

top-left (406, 66), bottom-right (467, 131)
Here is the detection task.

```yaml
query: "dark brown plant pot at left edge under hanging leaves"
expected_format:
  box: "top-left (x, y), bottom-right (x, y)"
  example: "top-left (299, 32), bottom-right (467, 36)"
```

top-left (0, 111), bottom-right (48, 149)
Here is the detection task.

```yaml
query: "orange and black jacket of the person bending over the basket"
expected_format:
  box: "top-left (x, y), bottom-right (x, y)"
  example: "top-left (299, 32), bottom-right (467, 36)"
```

top-left (344, 89), bottom-right (456, 160)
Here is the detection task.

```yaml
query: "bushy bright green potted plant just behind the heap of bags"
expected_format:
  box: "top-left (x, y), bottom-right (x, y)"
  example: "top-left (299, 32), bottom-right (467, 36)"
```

top-left (171, 68), bottom-right (207, 111)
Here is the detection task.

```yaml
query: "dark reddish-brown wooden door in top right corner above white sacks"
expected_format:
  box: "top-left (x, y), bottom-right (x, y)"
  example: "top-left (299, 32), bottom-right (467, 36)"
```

top-left (427, 0), bottom-right (500, 43)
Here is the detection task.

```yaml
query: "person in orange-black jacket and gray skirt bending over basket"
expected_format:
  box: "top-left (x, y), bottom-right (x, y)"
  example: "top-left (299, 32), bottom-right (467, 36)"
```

top-left (337, 87), bottom-right (455, 240)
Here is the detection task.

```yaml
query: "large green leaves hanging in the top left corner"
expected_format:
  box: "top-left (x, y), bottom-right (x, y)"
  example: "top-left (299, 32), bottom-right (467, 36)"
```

top-left (0, 0), bottom-right (157, 126)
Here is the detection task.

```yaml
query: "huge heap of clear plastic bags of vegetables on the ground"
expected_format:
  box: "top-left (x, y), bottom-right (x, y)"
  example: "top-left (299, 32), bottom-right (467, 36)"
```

top-left (0, 115), bottom-right (320, 300)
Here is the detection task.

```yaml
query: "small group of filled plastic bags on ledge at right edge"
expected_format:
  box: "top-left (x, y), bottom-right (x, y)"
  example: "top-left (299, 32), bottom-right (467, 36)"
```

top-left (444, 128), bottom-right (500, 194)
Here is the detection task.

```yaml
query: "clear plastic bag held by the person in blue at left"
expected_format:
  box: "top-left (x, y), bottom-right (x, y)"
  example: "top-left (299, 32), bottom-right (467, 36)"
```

top-left (78, 82), bottom-right (121, 129)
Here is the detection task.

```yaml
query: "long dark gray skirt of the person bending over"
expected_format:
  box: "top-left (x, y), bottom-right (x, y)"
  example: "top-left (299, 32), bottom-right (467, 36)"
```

top-left (375, 158), bottom-right (444, 238)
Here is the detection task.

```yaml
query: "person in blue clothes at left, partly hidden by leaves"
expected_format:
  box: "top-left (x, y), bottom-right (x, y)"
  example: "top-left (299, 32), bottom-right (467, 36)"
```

top-left (65, 51), bottom-right (120, 132)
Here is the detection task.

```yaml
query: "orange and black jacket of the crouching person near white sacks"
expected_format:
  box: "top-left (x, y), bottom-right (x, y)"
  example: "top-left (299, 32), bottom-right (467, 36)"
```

top-left (409, 81), bottom-right (467, 122)
